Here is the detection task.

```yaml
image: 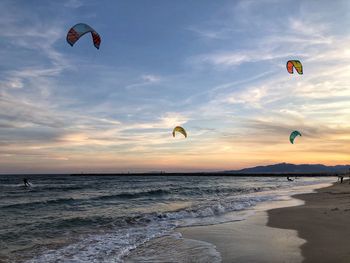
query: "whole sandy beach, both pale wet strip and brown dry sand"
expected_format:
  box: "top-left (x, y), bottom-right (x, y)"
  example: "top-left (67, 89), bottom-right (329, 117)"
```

top-left (180, 181), bottom-right (350, 263)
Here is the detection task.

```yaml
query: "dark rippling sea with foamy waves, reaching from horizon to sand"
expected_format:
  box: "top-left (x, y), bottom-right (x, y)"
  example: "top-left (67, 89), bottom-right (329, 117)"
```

top-left (0, 174), bottom-right (335, 263)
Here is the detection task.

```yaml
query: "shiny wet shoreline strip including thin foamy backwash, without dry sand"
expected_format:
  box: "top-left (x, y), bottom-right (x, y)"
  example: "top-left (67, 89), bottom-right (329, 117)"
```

top-left (124, 199), bottom-right (305, 263)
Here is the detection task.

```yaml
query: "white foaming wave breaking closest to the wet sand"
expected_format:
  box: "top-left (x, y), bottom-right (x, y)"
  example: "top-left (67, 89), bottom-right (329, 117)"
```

top-left (28, 196), bottom-right (272, 263)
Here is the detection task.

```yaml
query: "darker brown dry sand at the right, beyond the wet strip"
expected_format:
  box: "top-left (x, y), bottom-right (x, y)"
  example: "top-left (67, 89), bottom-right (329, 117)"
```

top-left (268, 181), bottom-right (350, 263)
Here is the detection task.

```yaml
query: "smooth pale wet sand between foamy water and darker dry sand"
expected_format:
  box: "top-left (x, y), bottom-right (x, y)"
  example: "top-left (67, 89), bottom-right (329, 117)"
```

top-left (178, 199), bottom-right (305, 263)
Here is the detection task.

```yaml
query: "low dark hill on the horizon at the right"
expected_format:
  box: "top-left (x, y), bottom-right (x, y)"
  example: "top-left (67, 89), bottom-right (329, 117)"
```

top-left (224, 163), bottom-right (350, 174)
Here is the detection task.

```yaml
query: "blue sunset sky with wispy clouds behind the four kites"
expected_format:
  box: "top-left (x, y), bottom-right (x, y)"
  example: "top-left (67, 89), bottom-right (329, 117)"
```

top-left (0, 0), bottom-right (350, 174)
